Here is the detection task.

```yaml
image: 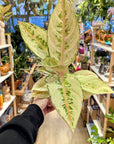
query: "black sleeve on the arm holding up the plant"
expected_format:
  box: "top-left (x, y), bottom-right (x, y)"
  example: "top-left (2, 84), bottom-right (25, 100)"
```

top-left (0, 104), bottom-right (44, 144)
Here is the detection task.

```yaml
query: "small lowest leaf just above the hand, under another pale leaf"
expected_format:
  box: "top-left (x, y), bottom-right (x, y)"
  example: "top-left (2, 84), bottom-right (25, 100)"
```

top-left (31, 91), bottom-right (49, 99)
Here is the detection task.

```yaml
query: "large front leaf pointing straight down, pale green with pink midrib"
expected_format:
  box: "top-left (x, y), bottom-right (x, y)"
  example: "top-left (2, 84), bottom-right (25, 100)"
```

top-left (46, 73), bottom-right (83, 131)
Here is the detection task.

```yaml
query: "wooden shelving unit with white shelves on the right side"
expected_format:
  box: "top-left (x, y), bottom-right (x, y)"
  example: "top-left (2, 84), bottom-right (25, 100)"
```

top-left (87, 27), bottom-right (114, 137)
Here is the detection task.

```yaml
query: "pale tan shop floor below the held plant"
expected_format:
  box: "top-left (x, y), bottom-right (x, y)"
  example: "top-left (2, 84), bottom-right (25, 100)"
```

top-left (35, 110), bottom-right (89, 144)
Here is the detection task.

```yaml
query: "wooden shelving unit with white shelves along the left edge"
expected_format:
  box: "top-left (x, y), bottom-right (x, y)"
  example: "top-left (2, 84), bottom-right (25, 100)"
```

top-left (0, 34), bottom-right (16, 117)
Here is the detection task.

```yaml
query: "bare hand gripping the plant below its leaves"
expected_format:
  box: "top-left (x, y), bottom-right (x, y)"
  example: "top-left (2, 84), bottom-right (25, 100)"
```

top-left (33, 98), bottom-right (55, 115)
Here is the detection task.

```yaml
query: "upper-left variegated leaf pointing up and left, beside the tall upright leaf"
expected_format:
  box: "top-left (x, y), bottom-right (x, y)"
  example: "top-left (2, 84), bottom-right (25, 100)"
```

top-left (19, 22), bottom-right (48, 59)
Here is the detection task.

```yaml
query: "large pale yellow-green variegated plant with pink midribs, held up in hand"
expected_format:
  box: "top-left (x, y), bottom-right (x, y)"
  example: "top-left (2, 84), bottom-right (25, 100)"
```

top-left (19, 0), bottom-right (113, 131)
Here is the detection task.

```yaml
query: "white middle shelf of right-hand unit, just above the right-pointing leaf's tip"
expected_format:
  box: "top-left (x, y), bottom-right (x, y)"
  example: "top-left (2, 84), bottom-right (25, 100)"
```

top-left (90, 66), bottom-right (114, 86)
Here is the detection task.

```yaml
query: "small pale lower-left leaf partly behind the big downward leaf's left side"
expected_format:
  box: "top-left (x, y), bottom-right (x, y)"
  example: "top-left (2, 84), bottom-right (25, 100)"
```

top-left (32, 77), bottom-right (48, 92)
